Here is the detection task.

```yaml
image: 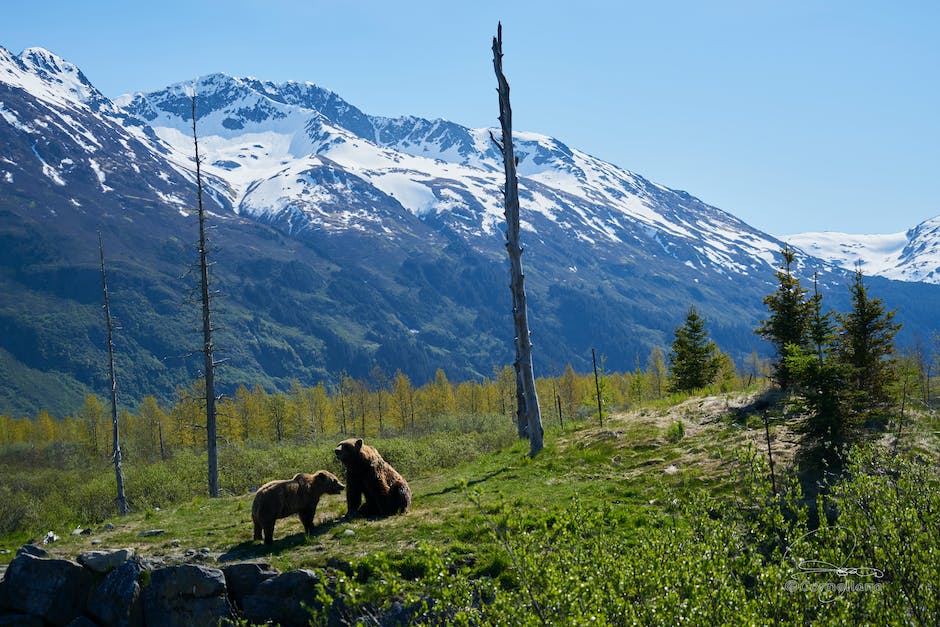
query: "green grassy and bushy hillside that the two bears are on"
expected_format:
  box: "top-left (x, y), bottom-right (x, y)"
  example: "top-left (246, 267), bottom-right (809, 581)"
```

top-left (0, 392), bottom-right (940, 624)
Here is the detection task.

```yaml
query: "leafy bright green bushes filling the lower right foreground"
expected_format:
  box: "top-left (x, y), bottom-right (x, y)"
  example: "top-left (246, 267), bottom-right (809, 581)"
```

top-left (340, 449), bottom-right (940, 625)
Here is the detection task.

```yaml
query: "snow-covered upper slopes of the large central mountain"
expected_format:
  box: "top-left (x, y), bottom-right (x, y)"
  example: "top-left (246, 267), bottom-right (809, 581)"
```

top-left (119, 74), bottom-right (792, 274)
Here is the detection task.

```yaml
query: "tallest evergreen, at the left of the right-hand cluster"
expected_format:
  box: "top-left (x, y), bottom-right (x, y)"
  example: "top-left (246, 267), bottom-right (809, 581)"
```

top-left (755, 246), bottom-right (810, 390)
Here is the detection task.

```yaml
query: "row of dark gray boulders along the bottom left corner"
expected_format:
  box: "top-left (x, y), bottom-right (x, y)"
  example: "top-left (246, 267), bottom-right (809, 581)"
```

top-left (0, 545), bottom-right (340, 627)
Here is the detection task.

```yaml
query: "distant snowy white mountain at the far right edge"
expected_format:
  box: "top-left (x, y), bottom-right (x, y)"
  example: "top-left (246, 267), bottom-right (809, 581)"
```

top-left (780, 216), bottom-right (940, 284)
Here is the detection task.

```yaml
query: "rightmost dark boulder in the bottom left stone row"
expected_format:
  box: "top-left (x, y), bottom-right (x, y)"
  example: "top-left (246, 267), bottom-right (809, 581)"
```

top-left (242, 570), bottom-right (323, 627)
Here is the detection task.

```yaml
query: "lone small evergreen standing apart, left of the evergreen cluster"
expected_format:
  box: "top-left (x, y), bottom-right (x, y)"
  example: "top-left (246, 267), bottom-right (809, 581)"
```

top-left (669, 305), bottom-right (720, 392)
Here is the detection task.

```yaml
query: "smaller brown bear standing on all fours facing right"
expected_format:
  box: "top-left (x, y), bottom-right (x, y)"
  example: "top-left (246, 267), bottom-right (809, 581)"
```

top-left (251, 470), bottom-right (346, 544)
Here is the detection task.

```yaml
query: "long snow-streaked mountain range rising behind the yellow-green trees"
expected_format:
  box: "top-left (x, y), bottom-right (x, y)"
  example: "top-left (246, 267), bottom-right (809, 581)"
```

top-left (0, 48), bottom-right (940, 413)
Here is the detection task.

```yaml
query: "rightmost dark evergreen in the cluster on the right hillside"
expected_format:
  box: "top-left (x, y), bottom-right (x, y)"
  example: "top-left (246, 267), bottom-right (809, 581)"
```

top-left (838, 268), bottom-right (901, 406)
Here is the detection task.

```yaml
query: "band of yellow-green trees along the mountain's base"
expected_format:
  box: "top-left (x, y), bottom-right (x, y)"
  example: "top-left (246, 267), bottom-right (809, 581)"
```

top-left (0, 356), bottom-right (756, 454)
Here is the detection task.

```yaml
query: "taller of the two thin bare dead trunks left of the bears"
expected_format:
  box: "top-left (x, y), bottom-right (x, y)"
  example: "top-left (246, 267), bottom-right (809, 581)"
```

top-left (192, 94), bottom-right (219, 498)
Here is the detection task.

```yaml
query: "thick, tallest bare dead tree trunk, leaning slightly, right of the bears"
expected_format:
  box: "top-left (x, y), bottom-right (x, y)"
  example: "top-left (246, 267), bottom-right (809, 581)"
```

top-left (490, 23), bottom-right (543, 455)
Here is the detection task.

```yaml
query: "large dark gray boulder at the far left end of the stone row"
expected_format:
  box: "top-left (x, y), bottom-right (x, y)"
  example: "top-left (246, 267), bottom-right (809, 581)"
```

top-left (4, 552), bottom-right (93, 625)
